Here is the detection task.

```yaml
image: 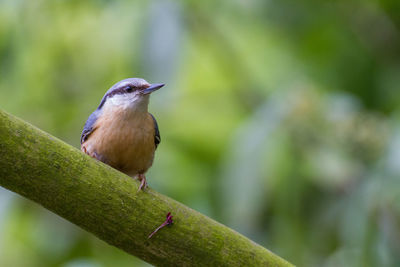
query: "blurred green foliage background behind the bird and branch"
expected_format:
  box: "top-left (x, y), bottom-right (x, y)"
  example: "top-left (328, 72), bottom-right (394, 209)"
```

top-left (0, 0), bottom-right (400, 267)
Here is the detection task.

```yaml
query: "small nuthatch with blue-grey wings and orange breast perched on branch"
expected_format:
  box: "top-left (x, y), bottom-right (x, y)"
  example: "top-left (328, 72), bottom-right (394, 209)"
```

top-left (81, 78), bottom-right (165, 191)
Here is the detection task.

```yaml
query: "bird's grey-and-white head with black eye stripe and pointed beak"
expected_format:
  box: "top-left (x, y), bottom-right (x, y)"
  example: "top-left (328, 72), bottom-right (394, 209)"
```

top-left (98, 78), bottom-right (164, 111)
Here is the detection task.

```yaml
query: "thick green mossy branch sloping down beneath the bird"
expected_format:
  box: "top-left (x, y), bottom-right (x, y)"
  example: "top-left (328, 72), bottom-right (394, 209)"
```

top-left (0, 110), bottom-right (291, 266)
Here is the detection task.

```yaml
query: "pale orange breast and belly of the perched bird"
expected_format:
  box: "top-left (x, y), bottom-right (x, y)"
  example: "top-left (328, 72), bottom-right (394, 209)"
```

top-left (83, 109), bottom-right (156, 176)
